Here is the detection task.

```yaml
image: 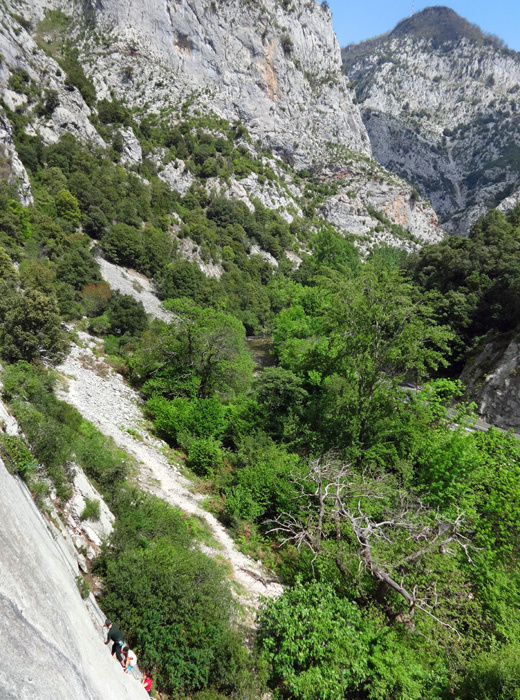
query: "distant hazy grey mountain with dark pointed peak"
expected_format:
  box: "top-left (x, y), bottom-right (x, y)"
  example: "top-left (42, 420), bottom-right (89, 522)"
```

top-left (343, 7), bottom-right (520, 235)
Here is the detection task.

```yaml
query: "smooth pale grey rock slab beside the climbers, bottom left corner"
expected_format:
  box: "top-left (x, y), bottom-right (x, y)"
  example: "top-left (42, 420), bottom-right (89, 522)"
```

top-left (0, 461), bottom-right (148, 700)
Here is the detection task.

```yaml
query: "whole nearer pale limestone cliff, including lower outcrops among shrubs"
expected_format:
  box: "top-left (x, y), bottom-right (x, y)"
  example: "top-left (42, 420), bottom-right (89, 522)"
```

top-left (0, 0), bottom-right (442, 247)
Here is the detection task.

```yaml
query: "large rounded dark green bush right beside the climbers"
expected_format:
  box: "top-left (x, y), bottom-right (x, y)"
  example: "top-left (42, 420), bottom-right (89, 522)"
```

top-left (101, 538), bottom-right (248, 697)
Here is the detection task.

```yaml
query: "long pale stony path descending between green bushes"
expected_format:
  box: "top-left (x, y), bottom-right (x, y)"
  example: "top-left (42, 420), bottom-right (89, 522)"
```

top-left (58, 333), bottom-right (282, 608)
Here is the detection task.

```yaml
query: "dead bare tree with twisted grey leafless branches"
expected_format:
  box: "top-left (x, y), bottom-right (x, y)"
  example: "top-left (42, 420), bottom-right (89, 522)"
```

top-left (270, 455), bottom-right (474, 635)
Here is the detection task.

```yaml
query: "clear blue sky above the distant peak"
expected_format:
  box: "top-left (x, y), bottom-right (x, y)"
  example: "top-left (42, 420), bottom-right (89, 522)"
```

top-left (328, 0), bottom-right (520, 51)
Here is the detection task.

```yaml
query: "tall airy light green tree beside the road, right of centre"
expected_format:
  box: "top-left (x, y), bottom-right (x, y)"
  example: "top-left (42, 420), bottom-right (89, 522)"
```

top-left (274, 264), bottom-right (452, 461)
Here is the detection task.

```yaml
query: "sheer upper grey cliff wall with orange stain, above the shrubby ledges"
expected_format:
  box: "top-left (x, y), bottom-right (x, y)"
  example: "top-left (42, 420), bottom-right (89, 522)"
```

top-left (76, 0), bottom-right (370, 167)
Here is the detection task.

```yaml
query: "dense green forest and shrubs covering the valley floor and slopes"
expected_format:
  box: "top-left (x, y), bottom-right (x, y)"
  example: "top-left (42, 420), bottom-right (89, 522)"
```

top-left (0, 93), bottom-right (520, 700)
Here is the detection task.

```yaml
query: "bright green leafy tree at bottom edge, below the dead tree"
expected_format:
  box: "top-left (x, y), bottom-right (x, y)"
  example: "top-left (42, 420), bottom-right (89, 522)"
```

top-left (258, 580), bottom-right (442, 700)
